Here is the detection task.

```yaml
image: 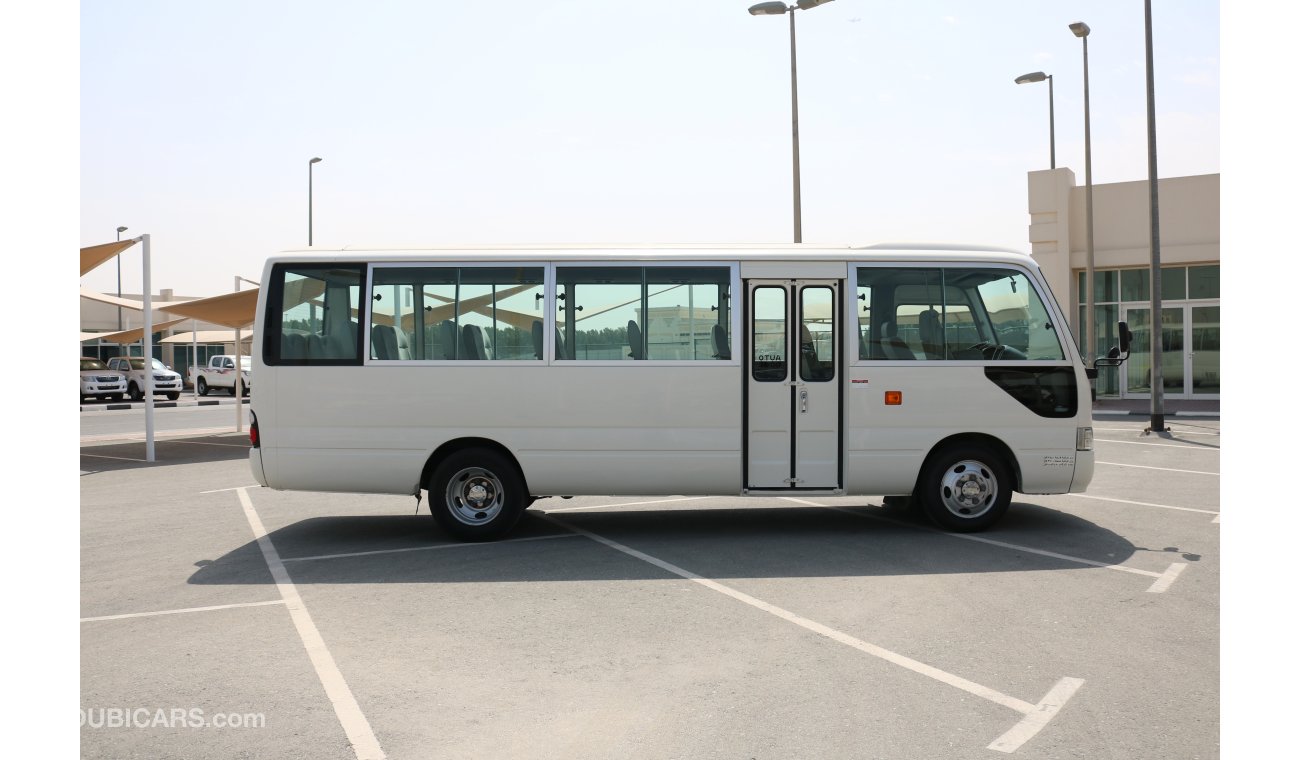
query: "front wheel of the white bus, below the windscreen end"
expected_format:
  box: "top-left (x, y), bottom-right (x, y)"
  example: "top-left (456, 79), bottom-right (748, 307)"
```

top-left (917, 444), bottom-right (1013, 533)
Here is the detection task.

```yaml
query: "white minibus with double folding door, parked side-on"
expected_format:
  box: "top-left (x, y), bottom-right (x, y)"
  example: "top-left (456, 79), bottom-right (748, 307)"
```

top-left (250, 244), bottom-right (1127, 540)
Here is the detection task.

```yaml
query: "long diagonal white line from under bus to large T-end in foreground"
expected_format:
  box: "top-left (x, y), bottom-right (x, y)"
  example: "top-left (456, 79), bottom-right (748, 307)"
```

top-left (542, 514), bottom-right (1083, 752)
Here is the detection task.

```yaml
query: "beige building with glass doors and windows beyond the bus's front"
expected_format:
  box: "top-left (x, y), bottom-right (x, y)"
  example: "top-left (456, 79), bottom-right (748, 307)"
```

top-left (1028, 169), bottom-right (1219, 399)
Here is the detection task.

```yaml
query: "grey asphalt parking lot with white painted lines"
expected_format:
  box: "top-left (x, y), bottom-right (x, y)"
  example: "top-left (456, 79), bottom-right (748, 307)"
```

top-left (81, 417), bottom-right (1221, 759)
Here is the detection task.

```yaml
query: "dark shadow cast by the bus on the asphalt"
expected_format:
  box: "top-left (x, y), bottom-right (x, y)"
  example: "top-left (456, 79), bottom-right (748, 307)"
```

top-left (189, 503), bottom-right (1139, 585)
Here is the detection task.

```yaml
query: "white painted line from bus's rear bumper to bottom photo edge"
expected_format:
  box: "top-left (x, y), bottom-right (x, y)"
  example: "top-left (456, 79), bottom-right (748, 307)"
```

top-left (235, 488), bottom-right (385, 760)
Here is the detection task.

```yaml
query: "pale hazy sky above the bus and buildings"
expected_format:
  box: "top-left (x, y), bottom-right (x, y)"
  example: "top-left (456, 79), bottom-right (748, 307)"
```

top-left (79, 0), bottom-right (1219, 295)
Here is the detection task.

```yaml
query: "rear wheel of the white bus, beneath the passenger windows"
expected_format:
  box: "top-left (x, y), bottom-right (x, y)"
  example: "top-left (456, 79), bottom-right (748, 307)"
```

top-left (428, 448), bottom-right (528, 540)
